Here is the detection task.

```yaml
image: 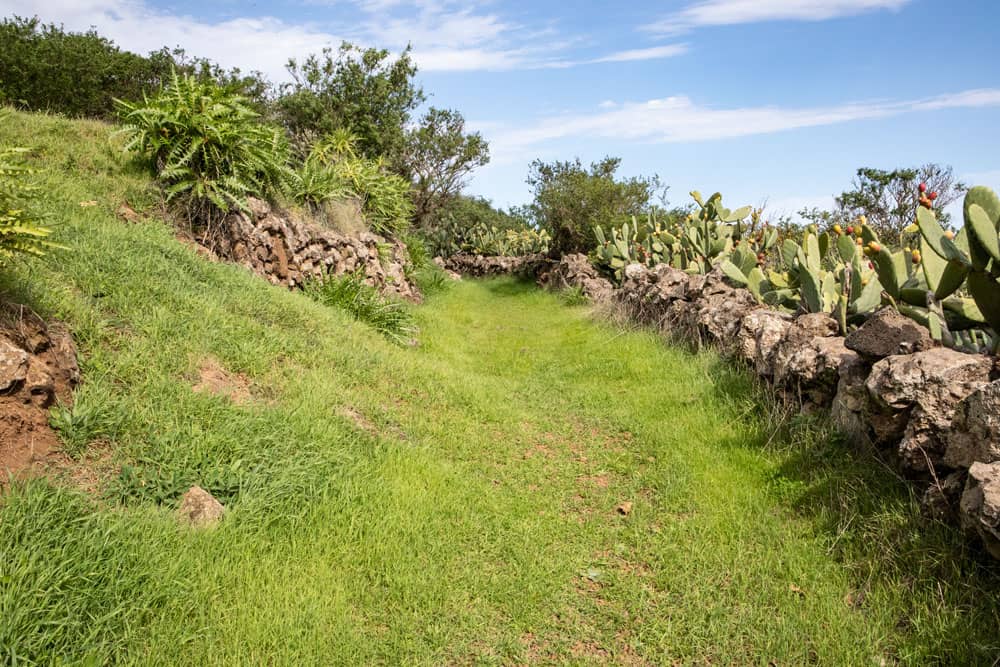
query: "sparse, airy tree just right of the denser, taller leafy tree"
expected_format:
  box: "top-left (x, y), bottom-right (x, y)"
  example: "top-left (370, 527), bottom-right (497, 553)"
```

top-left (402, 107), bottom-right (490, 224)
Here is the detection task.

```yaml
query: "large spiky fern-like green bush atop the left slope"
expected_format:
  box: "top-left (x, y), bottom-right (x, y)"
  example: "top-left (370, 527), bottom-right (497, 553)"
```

top-left (118, 72), bottom-right (289, 222)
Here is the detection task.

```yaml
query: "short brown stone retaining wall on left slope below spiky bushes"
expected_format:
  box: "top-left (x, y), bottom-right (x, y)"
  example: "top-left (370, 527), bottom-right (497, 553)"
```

top-left (200, 199), bottom-right (421, 301)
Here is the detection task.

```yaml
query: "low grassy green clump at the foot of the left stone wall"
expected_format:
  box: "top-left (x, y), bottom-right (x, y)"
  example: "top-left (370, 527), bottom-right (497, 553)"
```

top-left (305, 271), bottom-right (417, 345)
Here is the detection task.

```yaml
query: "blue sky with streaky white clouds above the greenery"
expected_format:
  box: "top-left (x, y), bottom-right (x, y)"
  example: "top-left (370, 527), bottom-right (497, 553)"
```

top-left (7, 0), bottom-right (1000, 219)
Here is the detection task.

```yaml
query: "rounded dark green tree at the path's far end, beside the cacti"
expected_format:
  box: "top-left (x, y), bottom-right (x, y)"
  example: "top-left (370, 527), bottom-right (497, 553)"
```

top-left (527, 157), bottom-right (662, 256)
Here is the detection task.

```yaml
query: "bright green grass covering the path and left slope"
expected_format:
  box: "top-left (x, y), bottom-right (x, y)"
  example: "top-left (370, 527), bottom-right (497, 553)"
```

top-left (0, 107), bottom-right (1000, 665)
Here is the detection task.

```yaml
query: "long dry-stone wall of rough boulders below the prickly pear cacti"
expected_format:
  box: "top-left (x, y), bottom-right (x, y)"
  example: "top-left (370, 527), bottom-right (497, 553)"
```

top-left (541, 255), bottom-right (1000, 558)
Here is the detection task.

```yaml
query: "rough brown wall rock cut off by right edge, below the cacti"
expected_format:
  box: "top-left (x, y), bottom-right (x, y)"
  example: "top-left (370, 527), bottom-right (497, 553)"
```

top-left (944, 380), bottom-right (1000, 468)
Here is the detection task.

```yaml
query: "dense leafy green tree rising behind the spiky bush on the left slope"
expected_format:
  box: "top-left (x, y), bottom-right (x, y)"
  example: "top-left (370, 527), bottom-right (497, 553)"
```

top-left (277, 42), bottom-right (425, 165)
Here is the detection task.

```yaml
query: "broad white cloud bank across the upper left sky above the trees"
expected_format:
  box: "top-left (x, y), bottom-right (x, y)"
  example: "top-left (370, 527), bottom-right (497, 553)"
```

top-left (0, 0), bottom-right (686, 74)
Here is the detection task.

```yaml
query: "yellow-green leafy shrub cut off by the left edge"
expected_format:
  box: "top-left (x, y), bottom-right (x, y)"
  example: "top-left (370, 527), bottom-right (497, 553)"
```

top-left (0, 144), bottom-right (60, 266)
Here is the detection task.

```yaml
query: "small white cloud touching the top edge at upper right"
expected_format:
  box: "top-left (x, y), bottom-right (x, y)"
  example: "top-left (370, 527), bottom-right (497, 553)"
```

top-left (646, 0), bottom-right (912, 34)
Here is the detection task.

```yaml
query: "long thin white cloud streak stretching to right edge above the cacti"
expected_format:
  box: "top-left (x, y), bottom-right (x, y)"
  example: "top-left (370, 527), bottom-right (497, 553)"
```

top-left (489, 88), bottom-right (1000, 162)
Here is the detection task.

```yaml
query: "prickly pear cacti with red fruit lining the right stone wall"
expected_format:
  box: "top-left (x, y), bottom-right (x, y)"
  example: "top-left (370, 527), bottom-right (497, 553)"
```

top-left (595, 185), bottom-right (1000, 350)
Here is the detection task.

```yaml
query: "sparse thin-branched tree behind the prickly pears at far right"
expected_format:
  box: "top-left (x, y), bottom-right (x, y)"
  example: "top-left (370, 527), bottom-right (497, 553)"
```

top-left (835, 163), bottom-right (967, 242)
